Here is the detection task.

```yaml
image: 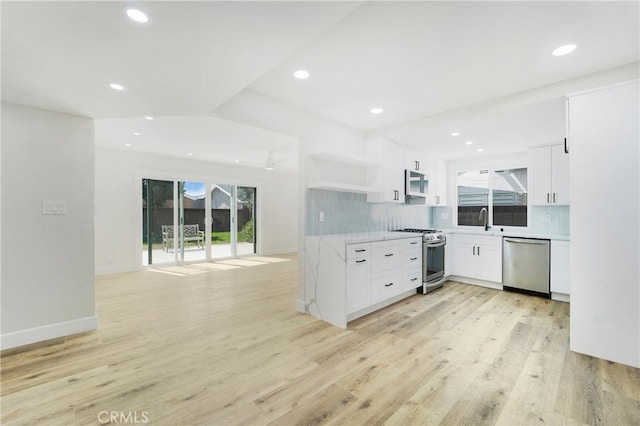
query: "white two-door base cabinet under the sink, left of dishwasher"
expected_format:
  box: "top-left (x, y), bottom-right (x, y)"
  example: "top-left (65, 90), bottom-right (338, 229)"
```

top-left (453, 234), bottom-right (502, 283)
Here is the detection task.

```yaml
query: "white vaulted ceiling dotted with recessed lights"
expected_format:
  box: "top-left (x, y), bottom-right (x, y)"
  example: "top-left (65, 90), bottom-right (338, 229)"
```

top-left (2, 1), bottom-right (640, 167)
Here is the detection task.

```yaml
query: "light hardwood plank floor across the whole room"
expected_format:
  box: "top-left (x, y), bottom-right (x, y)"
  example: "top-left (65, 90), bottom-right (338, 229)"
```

top-left (1, 255), bottom-right (640, 425)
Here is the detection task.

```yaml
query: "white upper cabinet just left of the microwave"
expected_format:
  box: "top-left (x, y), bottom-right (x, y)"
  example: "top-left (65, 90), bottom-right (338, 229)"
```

top-left (367, 137), bottom-right (405, 204)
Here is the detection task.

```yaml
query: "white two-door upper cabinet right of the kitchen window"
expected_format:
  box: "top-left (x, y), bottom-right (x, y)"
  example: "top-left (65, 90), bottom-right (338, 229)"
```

top-left (529, 145), bottom-right (569, 205)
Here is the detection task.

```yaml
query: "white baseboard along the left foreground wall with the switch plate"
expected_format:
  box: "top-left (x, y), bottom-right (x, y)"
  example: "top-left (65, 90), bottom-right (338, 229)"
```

top-left (0, 316), bottom-right (98, 350)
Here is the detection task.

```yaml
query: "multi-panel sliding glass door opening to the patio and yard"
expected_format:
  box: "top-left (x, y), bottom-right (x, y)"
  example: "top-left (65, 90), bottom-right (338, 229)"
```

top-left (142, 178), bottom-right (257, 265)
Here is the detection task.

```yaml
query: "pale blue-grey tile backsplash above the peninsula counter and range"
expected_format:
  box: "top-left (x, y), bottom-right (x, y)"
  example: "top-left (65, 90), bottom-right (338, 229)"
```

top-left (305, 189), bottom-right (430, 235)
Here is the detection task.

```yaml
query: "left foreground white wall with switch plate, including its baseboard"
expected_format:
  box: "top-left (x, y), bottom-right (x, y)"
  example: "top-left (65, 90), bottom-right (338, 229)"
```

top-left (1, 103), bottom-right (97, 349)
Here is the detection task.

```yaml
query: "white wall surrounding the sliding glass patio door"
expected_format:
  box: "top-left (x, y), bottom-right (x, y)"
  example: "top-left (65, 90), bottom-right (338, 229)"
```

top-left (95, 147), bottom-right (298, 274)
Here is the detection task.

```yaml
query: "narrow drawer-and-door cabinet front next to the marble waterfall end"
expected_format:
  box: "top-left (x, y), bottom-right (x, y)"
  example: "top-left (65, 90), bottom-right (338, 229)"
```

top-left (347, 243), bottom-right (371, 314)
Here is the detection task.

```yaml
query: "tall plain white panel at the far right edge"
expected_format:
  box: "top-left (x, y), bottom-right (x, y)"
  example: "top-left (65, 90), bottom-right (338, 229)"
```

top-left (568, 80), bottom-right (640, 368)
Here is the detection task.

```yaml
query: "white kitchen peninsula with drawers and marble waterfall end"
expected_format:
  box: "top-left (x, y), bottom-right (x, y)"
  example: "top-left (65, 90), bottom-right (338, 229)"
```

top-left (298, 232), bottom-right (422, 328)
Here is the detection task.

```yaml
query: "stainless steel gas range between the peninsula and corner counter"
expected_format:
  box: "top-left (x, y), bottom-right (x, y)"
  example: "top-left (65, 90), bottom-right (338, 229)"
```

top-left (398, 228), bottom-right (447, 294)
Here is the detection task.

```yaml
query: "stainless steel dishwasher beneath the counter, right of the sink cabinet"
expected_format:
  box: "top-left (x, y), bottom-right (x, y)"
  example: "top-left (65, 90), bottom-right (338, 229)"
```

top-left (502, 237), bottom-right (551, 297)
